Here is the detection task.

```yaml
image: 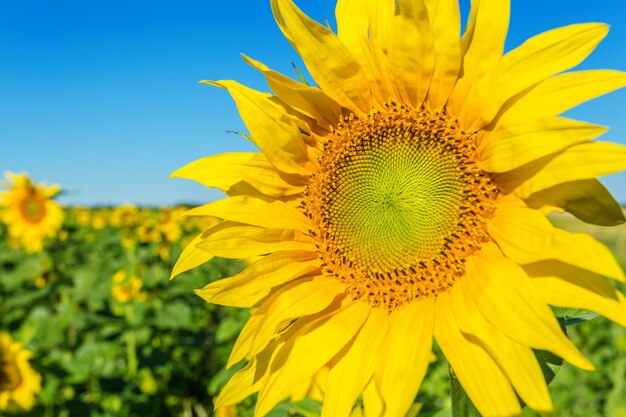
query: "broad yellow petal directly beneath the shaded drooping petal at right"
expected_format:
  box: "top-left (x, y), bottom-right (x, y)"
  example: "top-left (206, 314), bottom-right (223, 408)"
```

top-left (488, 195), bottom-right (625, 281)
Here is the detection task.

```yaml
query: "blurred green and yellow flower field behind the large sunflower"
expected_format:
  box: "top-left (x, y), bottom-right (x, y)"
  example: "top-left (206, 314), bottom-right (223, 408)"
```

top-left (0, 176), bottom-right (626, 417)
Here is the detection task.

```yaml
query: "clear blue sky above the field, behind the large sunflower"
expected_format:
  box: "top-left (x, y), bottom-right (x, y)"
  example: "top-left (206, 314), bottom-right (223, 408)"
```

top-left (0, 0), bottom-right (626, 205)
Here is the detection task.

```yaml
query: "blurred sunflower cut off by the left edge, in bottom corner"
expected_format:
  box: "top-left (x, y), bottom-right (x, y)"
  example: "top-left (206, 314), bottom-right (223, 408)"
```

top-left (0, 332), bottom-right (41, 411)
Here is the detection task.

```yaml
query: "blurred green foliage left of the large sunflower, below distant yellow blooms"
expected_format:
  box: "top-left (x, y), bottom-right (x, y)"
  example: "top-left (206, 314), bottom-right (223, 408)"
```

top-left (0, 216), bottom-right (248, 417)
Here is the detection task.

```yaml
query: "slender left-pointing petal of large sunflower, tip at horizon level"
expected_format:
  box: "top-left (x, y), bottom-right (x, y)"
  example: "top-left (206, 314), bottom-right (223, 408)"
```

top-left (182, 195), bottom-right (310, 232)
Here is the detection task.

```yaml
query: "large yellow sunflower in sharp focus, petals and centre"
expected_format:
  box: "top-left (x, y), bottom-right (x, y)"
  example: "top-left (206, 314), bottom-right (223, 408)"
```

top-left (173, 0), bottom-right (626, 417)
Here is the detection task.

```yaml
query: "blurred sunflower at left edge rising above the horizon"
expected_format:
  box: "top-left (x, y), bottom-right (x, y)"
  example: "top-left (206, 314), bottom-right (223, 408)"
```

top-left (0, 172), bottom-right (63, 253)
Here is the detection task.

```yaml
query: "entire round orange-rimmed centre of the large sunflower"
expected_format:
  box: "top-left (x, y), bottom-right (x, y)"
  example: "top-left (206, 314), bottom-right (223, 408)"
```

top-left (303, 104), bottom-right (497, 310)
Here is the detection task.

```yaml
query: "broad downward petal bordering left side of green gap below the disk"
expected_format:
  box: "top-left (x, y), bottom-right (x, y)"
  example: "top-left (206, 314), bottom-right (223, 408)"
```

top-left (376, 299), bottom-right (435, 417)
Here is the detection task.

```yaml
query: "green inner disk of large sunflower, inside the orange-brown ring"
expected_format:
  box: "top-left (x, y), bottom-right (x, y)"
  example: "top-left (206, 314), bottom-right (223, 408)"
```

top-left (326, 137), bottom-right (464, 272)
